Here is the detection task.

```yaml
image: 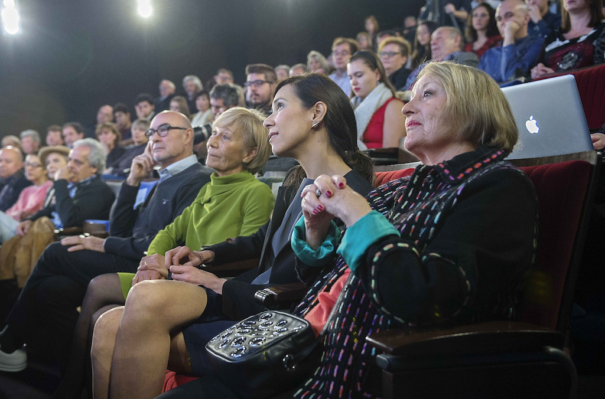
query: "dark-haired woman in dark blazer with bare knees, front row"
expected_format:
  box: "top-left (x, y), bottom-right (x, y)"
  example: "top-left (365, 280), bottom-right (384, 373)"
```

top-left (92, 74), bottom-right (373, 398)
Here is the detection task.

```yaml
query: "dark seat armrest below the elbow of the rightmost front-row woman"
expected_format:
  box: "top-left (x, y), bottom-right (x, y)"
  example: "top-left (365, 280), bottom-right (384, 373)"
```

top-left (366, 321), bottom-right (564, 357)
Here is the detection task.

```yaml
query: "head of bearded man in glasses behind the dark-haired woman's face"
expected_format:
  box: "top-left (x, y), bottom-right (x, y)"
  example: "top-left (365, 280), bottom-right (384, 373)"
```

top-left (244, 64), bottom-right (277, 115)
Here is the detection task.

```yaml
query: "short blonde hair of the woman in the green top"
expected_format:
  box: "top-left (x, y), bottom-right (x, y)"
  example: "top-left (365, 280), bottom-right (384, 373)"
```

top-left (212, 107), bottom-right (271, 174)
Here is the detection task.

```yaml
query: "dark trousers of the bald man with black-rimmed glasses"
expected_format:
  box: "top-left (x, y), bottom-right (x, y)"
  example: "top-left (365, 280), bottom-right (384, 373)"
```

top-left (6, 242), bottom-right (139, 368)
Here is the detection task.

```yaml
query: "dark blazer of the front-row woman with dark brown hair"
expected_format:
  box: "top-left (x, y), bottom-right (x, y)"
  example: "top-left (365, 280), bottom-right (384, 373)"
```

top-left (208, 170), bottom-right (373, 320)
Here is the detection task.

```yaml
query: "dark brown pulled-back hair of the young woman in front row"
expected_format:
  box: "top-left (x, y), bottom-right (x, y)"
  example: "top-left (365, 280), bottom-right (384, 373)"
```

top-left (275, 73), bottom-right (374, 195)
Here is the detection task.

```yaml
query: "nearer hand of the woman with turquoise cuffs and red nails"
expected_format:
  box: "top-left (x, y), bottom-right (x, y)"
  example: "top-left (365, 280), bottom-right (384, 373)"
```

top-left (315, 175), bottom-right (372, 227)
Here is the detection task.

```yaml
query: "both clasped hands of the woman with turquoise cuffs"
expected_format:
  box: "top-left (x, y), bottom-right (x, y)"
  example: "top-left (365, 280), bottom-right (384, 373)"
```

top-left (301, 175), bottom-right (372, 249)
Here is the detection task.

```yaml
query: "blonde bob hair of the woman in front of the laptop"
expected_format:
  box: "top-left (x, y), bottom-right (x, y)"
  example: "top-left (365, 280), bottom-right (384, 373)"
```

top-left (418, 61), bottom-right (519, 151)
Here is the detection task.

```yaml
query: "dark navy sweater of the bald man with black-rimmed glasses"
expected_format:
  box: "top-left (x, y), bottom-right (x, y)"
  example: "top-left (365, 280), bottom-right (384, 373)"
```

top-left (105, 163), bottom-right (210, 260)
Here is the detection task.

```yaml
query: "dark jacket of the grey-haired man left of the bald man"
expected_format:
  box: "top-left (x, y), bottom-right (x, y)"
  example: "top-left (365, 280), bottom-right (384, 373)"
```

top-left (29, 176), bottom-right (115, 227)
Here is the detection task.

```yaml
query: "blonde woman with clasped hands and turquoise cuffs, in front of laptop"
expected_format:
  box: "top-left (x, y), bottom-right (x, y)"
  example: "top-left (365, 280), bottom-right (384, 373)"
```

top-left (160, 62), bottom-right (538, 399)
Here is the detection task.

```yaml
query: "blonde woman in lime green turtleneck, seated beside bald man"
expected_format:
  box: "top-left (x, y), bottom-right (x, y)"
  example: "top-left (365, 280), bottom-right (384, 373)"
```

top-left (50, 107), bottom-right (274, 398)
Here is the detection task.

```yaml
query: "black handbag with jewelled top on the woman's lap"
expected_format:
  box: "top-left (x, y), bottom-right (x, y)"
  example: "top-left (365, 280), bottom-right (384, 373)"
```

top-left (206, 311), bottom-right (321, 399)
